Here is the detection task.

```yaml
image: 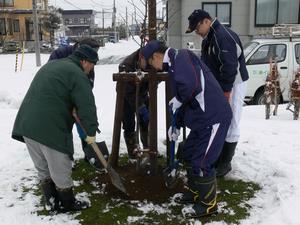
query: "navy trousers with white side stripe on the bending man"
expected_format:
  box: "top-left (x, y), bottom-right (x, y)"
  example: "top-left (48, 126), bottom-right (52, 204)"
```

top-left (183, 119), bottom-right (230, 177)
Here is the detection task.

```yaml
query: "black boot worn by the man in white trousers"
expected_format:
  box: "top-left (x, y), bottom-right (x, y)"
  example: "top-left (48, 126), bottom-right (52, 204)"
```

top-left (216, 141), bottom-right (237, 177)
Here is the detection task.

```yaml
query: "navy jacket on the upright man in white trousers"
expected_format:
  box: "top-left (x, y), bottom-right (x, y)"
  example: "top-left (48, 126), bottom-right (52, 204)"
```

top-left (201, 19), bottom-right (249, 92)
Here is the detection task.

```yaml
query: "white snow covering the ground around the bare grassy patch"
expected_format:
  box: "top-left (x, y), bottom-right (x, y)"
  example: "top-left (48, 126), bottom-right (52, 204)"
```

top-left (0, 37), bottom-right (300, 225)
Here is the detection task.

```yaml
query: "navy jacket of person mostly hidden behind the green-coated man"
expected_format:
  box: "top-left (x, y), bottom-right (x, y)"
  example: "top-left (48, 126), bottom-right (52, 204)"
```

top-left (48, 45), bottom-right (95, 88)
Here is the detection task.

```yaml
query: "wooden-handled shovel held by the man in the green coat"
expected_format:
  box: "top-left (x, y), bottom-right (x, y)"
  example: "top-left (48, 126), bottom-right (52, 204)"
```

top-left (73, 110), bottom-right (128, 195)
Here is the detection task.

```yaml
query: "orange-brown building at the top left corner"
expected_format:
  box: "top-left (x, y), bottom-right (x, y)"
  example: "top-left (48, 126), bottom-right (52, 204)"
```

top-left (0, 0), bottom-right (48, 41)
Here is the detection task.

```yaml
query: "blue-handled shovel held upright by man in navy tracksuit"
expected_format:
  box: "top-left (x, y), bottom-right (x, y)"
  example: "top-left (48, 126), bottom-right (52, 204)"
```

top-left (163, 111), bottom-right (179, 189)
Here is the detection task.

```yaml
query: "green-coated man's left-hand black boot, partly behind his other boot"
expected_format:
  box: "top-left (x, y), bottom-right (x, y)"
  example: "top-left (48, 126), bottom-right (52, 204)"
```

top-left (41, 178), bottom-right (59, 211)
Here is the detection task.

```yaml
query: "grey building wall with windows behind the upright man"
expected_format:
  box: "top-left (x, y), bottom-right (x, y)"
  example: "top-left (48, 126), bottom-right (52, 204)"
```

top-left (167, 0), bottom-right (300, 48)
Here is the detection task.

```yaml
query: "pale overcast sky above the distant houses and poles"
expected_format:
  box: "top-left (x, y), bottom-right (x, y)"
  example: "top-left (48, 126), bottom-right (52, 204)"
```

top-left (49, 0), bottom-right (161, 25)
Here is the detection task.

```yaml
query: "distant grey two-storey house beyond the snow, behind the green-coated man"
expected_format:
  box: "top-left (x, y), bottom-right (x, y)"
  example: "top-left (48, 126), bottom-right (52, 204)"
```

top-left (62, 10), bottom-right (96, 37)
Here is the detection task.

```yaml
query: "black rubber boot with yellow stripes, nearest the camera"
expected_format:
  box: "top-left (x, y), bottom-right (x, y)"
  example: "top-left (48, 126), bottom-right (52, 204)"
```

top-left (185, 176), bottom-right (218, 218)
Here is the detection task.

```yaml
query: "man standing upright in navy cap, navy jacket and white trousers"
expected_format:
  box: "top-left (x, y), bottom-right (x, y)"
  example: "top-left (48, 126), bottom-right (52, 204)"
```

top-left (186, 9), bottom-right (249, 177)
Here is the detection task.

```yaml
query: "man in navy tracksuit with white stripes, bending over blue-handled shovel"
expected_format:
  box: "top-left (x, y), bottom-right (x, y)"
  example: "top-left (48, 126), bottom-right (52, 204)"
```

top-left (141, 40), bottom-right (232, 217)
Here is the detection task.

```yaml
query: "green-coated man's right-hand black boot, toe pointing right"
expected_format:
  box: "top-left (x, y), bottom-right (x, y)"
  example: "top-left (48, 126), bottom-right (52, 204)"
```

top-left (57, 188), bottom-right (89, 212)
